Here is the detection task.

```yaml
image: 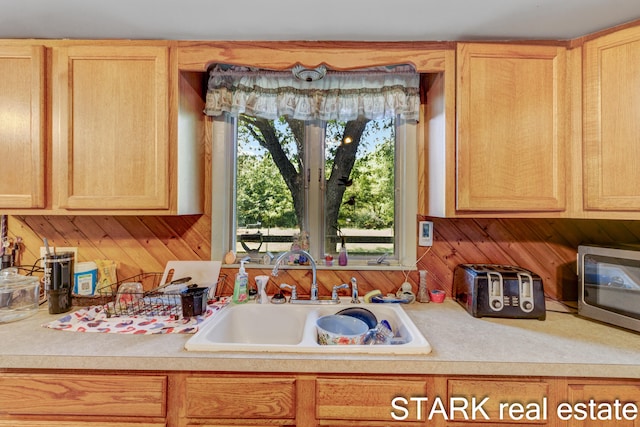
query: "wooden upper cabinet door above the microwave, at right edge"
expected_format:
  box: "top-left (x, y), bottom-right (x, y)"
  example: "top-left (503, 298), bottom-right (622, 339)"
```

top-left (583, 28), bottom-right (640, 211)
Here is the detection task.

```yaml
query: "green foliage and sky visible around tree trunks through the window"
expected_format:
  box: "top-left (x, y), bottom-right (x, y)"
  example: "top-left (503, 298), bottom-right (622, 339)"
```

top-left (236, 117), bottom-right (395, 229)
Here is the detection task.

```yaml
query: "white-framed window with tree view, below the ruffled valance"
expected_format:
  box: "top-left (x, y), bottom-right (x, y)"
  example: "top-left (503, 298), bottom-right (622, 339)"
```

top-left (212, 64), bottom-right (417, 265)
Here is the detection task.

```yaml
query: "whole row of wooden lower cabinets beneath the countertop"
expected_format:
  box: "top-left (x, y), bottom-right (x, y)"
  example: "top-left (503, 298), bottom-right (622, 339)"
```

top-left (0, 370), bottom-right (640, 427)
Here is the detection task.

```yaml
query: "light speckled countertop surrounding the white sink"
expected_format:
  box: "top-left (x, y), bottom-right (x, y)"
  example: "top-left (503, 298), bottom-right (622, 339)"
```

top-left (0, 300), bottom-right (640, 378)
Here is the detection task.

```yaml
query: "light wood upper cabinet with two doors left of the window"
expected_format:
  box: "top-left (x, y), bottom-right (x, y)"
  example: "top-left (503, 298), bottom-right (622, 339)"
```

top-left (0, 40), bottom-right (205, 215)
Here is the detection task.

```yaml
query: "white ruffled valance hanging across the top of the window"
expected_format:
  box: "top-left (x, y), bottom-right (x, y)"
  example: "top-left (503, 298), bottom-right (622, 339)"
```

top-left (205, 66), bottom-right (420, 121)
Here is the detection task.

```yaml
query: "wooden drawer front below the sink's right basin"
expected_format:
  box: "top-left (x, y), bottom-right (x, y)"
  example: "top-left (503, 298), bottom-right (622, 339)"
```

top-left (316, 378), bottom-right (427, 421)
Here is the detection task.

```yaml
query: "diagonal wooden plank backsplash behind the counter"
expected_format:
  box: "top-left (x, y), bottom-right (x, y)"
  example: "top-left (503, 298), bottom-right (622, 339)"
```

top-left (9, 214), bottom-right (640, 300)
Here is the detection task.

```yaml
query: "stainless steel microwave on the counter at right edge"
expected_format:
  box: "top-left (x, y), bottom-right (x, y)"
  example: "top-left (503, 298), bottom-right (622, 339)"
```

top-left (578, 245), bottom-right (640, 332)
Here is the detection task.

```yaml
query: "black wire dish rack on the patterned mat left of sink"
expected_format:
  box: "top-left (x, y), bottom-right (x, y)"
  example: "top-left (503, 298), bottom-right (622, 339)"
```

top-left (74, 273), bottom-right (226, 319)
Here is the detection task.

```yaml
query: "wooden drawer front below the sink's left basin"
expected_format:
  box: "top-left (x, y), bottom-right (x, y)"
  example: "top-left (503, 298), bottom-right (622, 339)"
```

top-left (185, 377), bottom-right (296, 419)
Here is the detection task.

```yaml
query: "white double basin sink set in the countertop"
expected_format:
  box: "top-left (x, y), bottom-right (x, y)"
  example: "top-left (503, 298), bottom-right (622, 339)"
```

top-left (185, 299), bottom-right (431, 354)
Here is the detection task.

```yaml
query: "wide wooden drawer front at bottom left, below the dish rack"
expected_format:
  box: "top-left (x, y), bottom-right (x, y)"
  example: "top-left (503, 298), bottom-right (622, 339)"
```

top-left (0, 372), bottom-right (167, 427)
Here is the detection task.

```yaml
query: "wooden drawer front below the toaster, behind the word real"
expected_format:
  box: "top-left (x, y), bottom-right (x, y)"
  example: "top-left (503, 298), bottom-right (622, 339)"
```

top-left (447, 379), bottom-right (549, 424)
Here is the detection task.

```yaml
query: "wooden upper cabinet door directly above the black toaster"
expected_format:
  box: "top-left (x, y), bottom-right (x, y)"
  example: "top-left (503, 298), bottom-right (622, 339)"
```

top-left (456, 43), bottom-right (567, 212)
